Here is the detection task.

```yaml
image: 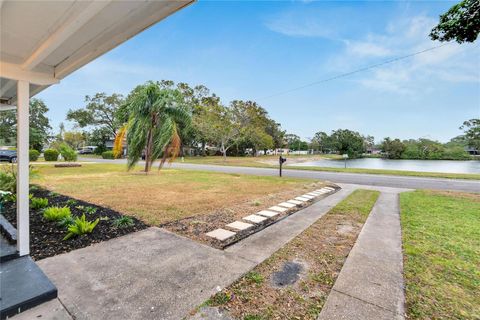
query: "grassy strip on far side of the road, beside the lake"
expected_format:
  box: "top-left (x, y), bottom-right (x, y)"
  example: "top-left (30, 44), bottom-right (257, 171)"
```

top-left (184, 155), bottom-right (480, 180)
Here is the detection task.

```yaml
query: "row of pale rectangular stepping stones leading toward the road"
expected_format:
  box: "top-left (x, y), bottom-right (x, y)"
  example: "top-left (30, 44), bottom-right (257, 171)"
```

top-left (206, 187), bottom-right (335, 245)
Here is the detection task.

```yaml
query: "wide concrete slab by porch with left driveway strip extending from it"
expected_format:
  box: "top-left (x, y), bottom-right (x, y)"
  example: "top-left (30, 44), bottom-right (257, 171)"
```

top-left (13, 185), bottom-right (408, 320)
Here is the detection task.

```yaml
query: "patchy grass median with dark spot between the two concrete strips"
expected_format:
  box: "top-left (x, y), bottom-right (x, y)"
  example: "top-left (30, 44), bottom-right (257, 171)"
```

top-left (199, 190), bottom-right (379, 319)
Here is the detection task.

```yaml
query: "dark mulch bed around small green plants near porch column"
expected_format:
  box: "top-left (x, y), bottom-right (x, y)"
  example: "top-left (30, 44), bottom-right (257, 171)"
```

top-left (2, 189), bottom-right (148, 260)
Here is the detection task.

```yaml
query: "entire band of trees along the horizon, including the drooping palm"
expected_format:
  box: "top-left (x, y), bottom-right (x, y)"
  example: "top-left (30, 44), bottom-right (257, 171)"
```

top-left (0, 80), bottom-right (480, 164)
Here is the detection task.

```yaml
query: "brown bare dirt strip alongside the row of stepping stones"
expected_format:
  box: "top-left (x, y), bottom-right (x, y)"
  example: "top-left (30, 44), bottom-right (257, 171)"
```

top-left (160, 182), bottom-right (325, 249)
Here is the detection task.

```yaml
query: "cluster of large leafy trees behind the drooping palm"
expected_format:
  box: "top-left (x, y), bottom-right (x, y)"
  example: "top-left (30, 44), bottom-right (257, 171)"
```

top-left (62, 80), bottom-right (285, 161)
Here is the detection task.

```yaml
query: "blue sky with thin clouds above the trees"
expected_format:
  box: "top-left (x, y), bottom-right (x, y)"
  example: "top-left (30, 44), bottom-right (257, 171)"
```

top-left (38, 0), bottom-right (480, 141)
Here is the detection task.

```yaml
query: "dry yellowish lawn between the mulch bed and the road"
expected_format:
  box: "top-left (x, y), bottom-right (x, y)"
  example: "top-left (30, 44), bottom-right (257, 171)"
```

top-left (32, 164), bottom-right (320, 225)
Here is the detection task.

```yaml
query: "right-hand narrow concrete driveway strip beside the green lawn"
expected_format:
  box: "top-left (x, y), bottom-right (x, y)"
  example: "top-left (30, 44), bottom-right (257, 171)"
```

top-left (318, 189), bottom-right (405, 320)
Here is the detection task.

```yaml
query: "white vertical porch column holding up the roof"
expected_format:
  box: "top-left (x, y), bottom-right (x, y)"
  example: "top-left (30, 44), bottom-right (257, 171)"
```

top-left (17, 80), bottom-right (30, 256)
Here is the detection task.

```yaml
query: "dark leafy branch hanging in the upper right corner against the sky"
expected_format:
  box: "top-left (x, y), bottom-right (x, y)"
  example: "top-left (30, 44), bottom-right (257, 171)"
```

top-left (430, 0), bottom-right (480, 43)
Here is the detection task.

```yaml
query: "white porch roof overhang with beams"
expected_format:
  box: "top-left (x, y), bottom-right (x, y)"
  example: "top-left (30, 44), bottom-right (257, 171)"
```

top-left (0, 0), bottom-right (194, 109)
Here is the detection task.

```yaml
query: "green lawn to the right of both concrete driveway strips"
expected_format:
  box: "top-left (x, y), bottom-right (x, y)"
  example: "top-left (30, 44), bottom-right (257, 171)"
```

top-left (400, 191), bottom-right (480, 319)
